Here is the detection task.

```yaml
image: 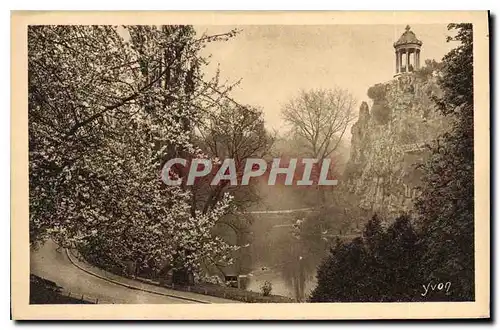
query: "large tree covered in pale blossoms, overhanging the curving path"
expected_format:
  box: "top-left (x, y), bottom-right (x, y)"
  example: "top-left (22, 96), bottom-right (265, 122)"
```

top-left (28, 26), bottom-right (242, 278)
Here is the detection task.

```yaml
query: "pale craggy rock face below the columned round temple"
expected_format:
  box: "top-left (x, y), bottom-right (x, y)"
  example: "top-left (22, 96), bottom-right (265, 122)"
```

top-left (344, 72), bottom-right (449, 219)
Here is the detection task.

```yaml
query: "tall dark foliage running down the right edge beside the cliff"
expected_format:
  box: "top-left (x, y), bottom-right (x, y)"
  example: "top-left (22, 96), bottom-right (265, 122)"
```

top-left (418, 24), bottom-right (474, 301)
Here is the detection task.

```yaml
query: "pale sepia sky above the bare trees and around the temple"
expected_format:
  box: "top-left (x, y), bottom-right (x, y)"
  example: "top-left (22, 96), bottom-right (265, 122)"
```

top-left (195, 24), bottom-right (454, 131)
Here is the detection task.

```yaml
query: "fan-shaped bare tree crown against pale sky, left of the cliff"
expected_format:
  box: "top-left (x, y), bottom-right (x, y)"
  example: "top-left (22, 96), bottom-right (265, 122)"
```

top-left (282, 88), bottom-right (356, 160)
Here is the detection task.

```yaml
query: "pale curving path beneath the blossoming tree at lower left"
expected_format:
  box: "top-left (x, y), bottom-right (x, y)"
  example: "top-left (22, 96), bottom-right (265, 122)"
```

top-left (30, 241), bottom-right (236, 304)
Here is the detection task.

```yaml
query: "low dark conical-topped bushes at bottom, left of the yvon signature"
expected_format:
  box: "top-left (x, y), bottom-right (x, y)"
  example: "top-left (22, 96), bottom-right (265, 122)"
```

top-left (310, 215), bottom-right (419, 302)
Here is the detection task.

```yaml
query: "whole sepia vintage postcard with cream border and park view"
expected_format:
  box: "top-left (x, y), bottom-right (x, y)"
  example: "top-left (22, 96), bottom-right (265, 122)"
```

top-left (11, 11), bottom-right (490, 320)
